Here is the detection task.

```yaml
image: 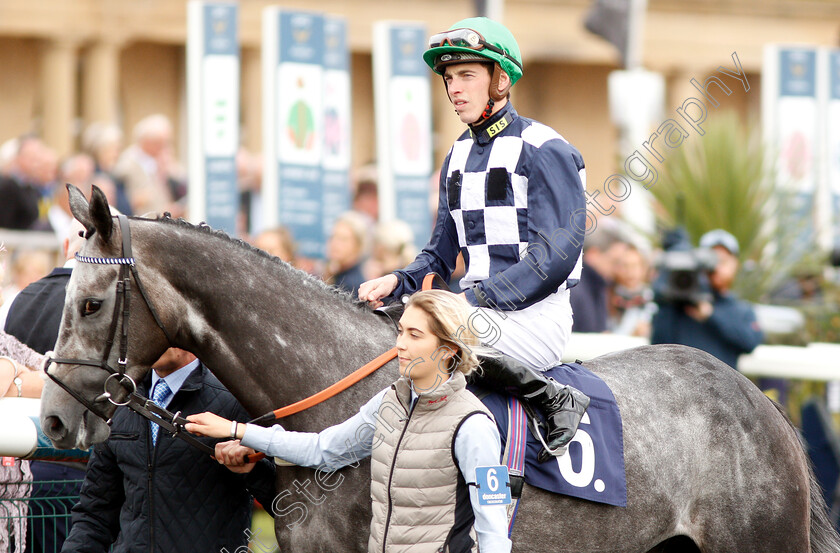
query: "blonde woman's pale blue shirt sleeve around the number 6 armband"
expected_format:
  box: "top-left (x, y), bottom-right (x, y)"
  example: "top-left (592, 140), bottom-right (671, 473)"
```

top-left (455, 414), bottom-right (511, 553)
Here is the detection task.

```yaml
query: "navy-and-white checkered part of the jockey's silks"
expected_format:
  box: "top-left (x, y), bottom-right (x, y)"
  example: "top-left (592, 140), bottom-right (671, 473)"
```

top-left (446, 121), bottom-right (586, 287)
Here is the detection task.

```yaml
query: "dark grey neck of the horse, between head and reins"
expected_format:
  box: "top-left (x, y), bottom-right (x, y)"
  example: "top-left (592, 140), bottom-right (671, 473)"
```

top-left (143, 222), bottom-right (395, 413)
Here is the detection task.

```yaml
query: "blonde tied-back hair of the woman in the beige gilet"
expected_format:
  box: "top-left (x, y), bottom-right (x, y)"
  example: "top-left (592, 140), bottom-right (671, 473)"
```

top-left (405, 290), bottom-right (485, 375)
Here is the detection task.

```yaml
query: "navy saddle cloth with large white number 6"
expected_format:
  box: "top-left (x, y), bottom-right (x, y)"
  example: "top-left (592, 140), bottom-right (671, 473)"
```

top-left (469, 363), bottom-right (627, 507)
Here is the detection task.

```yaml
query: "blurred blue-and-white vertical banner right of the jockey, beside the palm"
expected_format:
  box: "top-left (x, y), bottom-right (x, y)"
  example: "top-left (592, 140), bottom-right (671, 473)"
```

top-left (762, 46), bottom-right (819, 248)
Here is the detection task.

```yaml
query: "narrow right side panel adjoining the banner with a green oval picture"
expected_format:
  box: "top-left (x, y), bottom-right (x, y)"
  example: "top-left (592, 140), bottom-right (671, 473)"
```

top-left (321, 16), bottom-right (352, 236)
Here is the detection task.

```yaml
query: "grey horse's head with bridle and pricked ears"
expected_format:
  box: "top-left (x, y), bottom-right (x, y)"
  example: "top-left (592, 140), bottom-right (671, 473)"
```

top-left (41, 185), bottom-right (168, 448)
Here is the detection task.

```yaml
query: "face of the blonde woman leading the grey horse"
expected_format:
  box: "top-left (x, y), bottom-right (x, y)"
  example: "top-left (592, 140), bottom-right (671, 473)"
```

top-left (397, 306), bottom-right (454, 393)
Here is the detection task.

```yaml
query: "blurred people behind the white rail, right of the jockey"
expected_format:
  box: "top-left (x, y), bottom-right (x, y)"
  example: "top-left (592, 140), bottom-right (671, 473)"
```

top-left (571, 221), bottom-right (764, 374)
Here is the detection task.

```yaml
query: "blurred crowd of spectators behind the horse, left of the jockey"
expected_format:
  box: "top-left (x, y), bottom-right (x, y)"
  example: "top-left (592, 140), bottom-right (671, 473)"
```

top-left (0, 114), bottom-right (416, 310)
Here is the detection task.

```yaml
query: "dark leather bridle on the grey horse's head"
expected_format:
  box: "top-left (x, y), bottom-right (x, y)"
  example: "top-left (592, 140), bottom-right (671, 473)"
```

top-left (45, 215), bottom-right (173, 425)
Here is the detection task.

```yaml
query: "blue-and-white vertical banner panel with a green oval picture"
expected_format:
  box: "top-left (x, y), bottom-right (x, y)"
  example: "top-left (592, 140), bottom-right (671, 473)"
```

top-left (262, 7), bottom-right (325, 258)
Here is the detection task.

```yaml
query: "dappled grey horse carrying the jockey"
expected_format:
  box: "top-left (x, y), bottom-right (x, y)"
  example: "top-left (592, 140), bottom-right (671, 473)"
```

top-left (41, 187), bottom-right (840, 553)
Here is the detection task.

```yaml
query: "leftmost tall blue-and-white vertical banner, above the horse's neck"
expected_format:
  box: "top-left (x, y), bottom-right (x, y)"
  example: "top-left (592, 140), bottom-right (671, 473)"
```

top-left (187, 0), bottom-right (239, 235)
